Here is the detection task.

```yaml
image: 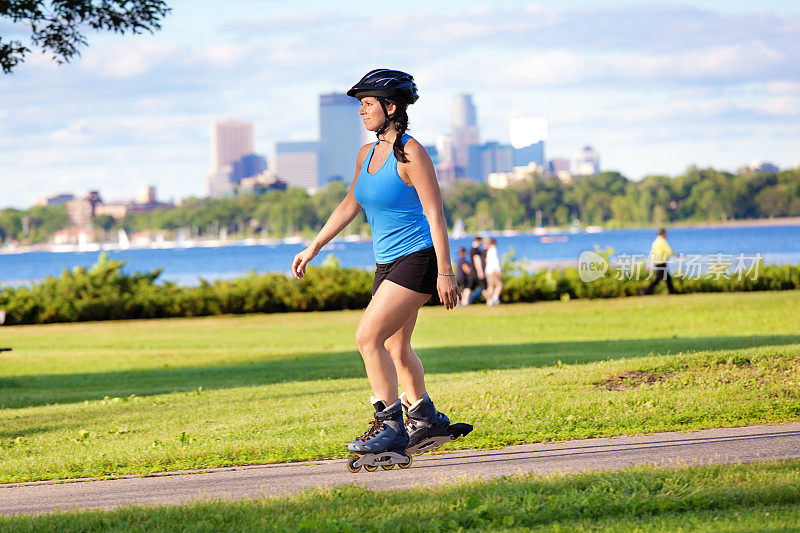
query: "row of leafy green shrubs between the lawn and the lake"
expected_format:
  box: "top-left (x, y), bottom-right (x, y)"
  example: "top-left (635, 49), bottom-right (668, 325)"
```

top-left (0, 254), bottom-right (800, 325)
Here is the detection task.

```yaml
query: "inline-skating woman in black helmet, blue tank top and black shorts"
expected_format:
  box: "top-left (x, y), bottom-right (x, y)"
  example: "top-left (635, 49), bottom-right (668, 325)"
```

top-left (292, 69), bottom-right (458, 471)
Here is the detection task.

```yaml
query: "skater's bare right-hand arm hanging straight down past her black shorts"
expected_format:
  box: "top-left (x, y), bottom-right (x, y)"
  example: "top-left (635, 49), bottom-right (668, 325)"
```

top-left (404, 139), bottom-right (458, 309)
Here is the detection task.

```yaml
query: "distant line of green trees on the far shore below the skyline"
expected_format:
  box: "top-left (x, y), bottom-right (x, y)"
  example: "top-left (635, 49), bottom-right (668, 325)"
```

top-left (0, 167), bottom-right (800, 242)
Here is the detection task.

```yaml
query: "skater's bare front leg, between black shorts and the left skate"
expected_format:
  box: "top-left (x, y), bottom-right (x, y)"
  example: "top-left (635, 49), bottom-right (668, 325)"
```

top-left (355, 280), bottom-right (430, 405)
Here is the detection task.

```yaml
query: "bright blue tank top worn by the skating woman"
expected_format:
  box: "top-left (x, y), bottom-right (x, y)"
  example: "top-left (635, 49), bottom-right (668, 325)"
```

top-left (353, 135), bottom-right (433, 264)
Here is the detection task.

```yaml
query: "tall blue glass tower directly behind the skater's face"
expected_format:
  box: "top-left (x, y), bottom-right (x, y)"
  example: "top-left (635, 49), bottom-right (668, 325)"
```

top-left (318, 93), bottom-right (365, 187)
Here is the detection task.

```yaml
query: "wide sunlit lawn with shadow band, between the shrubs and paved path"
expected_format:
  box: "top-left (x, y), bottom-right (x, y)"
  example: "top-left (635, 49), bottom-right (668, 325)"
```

top-left (0, 291), bottom-right (800, 482)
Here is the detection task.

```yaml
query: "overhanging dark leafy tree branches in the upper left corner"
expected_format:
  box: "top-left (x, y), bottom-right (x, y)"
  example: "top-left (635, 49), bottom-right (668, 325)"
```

top-left (0, 0), bottom-right (171, 74)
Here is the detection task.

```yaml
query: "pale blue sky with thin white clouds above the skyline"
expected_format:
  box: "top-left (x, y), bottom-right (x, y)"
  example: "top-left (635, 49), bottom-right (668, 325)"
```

top-left (0, 0), bottom-right (800, 208)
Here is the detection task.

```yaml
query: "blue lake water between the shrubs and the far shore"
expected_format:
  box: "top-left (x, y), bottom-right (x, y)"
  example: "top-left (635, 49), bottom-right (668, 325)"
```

top-left (0, 222), bottom-right (800, 285)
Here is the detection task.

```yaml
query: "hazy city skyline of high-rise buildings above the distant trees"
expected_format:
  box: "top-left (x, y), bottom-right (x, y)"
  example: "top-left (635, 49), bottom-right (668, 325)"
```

top-left (207, 93), bottom-right (552, 198)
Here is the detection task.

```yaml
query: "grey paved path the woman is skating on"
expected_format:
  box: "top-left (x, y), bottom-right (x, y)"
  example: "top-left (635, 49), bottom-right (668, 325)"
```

top-left (0, 422), bottom-right (800, 514)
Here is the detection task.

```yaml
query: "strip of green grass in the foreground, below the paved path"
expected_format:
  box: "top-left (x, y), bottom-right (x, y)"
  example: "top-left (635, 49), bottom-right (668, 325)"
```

top-left (0, 460), bottom-right (800, 532)
